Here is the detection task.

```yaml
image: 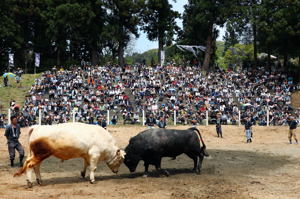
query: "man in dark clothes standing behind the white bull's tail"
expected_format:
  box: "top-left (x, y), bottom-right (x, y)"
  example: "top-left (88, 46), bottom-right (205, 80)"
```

top-left (4, 116), bottom-right (24, 167)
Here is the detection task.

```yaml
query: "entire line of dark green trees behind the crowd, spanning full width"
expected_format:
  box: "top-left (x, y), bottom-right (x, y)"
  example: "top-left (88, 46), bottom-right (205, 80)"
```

top-left (0, 0), bottom-right (300, 72)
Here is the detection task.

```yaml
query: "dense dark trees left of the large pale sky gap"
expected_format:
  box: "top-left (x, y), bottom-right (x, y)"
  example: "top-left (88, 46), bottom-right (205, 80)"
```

top-left (0, 0), bottom-right (143, 69)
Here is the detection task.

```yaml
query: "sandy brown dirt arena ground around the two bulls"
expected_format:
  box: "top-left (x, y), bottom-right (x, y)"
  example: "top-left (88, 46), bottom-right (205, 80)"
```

top-left (0, 126), bottom-right (300, 199)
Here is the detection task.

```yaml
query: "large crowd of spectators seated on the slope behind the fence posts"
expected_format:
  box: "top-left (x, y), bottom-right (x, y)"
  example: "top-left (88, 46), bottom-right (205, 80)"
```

top-left (1, 65), bottom-right (300, 126)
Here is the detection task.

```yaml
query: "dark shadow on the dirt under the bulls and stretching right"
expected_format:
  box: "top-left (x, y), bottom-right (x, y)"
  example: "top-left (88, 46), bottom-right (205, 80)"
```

top-left (20, 150), bottom-right (292, 185)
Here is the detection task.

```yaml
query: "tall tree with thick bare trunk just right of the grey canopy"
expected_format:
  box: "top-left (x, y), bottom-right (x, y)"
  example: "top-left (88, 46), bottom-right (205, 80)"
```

top-left (183, 0), bottom-right (238, 70)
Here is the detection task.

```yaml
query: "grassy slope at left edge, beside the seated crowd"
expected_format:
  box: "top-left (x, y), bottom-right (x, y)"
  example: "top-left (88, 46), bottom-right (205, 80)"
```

top-left (0, 74), bottom-right (40, 114)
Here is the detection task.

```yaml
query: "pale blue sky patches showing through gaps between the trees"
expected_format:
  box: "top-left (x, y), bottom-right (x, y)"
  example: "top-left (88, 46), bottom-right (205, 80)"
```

top-left (134, 0), bottom-right (224, 53)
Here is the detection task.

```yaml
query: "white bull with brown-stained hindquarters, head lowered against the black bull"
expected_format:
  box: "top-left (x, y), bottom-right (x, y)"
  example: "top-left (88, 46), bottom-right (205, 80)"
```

top-left (14, 123), bottom-right (125, 187)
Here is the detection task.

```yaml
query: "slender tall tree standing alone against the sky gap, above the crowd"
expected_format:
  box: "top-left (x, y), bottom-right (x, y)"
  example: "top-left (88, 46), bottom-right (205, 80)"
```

top-left (141, 0), bottom-right (180, 64)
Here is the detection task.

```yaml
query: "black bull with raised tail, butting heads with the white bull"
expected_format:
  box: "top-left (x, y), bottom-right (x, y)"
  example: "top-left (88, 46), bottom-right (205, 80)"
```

top-left (124, 127), bottom-right (208, 175)
